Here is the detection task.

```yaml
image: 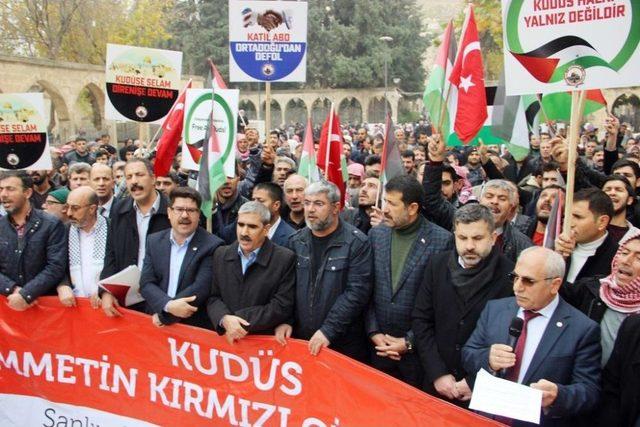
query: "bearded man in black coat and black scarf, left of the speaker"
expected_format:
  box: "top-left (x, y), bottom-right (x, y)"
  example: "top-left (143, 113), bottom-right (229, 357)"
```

top-left (412, 204), bottom-right (514, 405)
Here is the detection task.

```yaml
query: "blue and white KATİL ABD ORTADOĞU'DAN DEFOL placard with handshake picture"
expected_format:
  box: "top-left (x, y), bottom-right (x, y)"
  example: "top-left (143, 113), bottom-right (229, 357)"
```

top-left (229, 0), bottom-right (307, 82)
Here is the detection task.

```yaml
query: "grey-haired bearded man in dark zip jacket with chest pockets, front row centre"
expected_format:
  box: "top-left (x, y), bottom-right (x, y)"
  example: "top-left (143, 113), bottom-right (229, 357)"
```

top-left (276, 181), bottom-right (372, 361)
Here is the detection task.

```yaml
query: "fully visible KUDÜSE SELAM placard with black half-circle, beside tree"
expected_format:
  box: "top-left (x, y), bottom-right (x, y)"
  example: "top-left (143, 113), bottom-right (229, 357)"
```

top-left (105, 44), bottom-right (182, 123)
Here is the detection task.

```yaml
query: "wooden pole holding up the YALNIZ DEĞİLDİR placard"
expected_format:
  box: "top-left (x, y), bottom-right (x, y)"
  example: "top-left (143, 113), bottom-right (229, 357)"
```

top-left (562, 90), bottom-right (587, 235)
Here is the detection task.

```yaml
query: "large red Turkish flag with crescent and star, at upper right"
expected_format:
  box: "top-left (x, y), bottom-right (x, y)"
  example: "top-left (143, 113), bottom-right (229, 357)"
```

top-left (449, 5), bottom-right (487, 144)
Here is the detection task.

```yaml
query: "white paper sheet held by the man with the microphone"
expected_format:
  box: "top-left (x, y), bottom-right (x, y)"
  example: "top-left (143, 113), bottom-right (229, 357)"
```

top-left (469, 369), bottom-right (542, 424)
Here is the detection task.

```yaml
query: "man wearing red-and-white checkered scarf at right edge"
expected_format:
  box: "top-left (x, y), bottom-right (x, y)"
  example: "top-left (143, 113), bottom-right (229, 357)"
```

top-left (560, 229), bottom-right (640, 366)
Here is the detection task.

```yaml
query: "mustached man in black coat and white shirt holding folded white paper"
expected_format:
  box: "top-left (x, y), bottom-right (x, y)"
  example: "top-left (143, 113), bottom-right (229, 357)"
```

top-left (100, 157), bottom-right (171, 317)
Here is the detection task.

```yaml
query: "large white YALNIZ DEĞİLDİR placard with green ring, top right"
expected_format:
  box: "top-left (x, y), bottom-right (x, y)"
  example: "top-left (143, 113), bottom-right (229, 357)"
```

top-left (502, 0), bottom-right (640, 95)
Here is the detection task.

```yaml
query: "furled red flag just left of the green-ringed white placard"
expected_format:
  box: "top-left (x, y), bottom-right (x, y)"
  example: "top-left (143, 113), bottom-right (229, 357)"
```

top-left (153, 80), bottom-right (191, 176)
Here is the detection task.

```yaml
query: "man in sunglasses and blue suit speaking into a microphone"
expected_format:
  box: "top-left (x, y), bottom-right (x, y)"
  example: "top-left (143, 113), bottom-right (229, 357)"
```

top-left (462, 247), bottom-right (601, 426)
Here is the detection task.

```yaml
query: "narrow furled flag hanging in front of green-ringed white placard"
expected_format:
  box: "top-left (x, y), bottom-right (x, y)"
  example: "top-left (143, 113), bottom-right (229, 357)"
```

top-left (198, 60), bottom-right (227, 218)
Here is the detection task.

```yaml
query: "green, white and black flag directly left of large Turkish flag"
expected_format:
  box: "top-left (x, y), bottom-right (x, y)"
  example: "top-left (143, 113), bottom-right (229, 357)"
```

top-left (423, 21), bottom-right (457, 134)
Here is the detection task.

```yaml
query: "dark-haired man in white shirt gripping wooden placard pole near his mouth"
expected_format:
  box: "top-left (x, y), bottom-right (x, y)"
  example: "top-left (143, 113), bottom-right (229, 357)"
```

top-left (555, 188), bottom-right (618, 286)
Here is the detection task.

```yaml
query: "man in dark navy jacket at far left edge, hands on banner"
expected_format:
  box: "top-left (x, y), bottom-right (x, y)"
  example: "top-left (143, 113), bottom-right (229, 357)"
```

top-left (0, 171), bottom-right (67, 311)
